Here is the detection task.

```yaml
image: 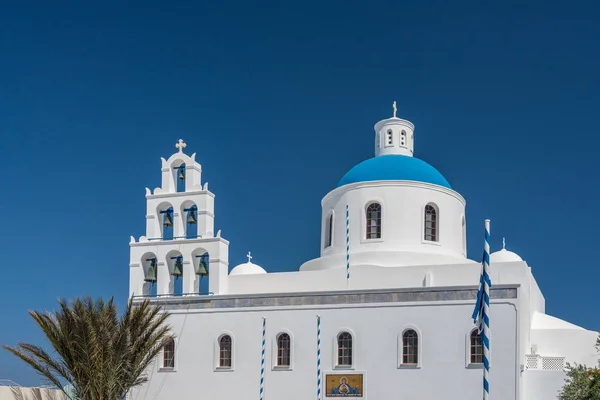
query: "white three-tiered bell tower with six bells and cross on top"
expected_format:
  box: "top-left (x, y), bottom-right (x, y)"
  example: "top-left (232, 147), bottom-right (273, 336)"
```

top-left (129, 139), bottom-right (229, 296)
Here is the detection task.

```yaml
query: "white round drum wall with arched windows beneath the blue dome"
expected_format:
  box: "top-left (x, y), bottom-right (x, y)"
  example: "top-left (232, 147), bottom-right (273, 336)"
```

top-left (316, 181), bottom-right (466, 270)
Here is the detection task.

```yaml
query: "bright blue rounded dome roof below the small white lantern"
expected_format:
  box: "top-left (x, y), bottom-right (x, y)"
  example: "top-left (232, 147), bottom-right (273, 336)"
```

top-left (338, 154), bottom-right (452, 189)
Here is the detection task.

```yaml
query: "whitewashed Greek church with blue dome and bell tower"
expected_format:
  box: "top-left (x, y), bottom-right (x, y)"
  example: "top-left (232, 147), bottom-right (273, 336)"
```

top-left (129, 106), bottom-right (598, 400)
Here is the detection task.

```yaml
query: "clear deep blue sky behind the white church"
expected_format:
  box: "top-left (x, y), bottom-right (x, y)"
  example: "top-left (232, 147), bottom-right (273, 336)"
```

top-left (0, 1), bottom-right (600, 385)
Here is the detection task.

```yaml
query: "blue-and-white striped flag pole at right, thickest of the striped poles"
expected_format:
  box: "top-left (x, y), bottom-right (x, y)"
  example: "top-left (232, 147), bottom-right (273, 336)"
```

top-left (473, 219), bottom-right (492, 400)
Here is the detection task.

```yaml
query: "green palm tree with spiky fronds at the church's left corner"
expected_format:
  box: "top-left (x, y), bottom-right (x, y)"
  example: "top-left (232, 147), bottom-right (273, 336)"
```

top-left (4, 297), bottom-right (171, 400)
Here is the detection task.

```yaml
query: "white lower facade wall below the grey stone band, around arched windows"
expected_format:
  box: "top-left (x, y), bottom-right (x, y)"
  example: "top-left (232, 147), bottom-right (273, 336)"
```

top-left (132, 290), bottom-right (517, 400)
